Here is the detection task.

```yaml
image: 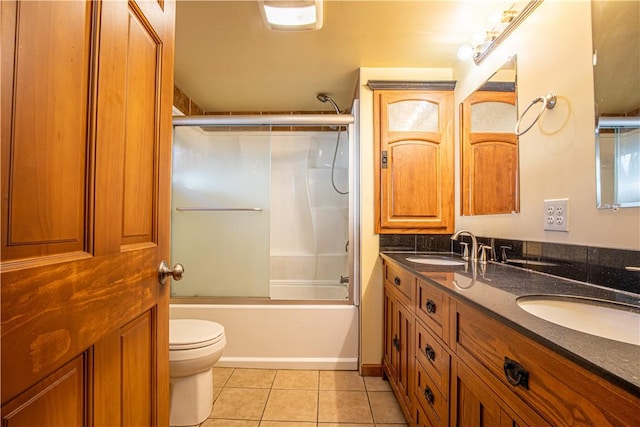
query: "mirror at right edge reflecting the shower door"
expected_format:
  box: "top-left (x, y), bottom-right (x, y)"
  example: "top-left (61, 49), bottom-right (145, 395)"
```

top-left (591, 0), bottom-right (640, 209)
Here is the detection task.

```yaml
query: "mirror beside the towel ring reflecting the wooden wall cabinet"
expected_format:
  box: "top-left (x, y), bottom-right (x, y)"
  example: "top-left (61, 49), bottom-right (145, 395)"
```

top-left (460, 56), bottom-right (520, 215)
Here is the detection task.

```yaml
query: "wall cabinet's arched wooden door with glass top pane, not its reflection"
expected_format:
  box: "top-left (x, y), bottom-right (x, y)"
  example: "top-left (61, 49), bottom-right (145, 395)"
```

top-left (374, 91), bottom-right (454, 233)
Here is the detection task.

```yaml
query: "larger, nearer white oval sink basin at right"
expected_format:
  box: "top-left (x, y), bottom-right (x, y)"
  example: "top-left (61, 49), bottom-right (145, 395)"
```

top-left (517, 295), bottom-right (640, 345)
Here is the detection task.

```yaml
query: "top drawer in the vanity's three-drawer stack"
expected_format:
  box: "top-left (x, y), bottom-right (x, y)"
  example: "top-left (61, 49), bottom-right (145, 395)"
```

top-left (415, 280), bottom-right (449, 342)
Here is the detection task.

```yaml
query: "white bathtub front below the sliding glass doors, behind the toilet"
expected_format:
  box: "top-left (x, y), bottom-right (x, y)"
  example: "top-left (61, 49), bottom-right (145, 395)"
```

top-left (170, 304), bottom-right (358, 370)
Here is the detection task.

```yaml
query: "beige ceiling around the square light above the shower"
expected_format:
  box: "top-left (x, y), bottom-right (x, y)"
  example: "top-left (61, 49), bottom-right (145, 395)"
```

top-left (175, 0), bottom-right (513, 112)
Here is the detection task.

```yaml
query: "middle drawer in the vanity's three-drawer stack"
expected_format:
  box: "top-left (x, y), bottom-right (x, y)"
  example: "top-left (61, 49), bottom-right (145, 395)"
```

top-left (415, 322), bottom-right (450, 395)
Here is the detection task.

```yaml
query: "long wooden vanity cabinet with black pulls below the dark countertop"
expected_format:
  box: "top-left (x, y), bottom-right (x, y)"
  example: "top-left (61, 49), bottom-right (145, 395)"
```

top-left (383, 259), bottom-right (640, 427)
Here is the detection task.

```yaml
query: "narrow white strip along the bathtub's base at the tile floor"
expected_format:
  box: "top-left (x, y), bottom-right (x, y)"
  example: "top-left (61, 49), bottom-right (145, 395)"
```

top-left (215, 356), bottom-right (358, 371)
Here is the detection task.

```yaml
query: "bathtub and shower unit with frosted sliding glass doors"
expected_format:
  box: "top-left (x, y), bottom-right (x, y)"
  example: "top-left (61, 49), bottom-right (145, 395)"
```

top-left (171, 102), bottom-right (358, 369)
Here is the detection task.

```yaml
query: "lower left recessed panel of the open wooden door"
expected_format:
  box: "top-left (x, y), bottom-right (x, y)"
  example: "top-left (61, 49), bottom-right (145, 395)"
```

top-left (2, 354), bottom-right (87, 427)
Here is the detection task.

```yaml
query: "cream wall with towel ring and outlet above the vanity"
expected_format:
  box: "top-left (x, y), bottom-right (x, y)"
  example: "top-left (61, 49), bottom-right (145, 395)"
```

top-left (454, 0), bottom-right (640, 250)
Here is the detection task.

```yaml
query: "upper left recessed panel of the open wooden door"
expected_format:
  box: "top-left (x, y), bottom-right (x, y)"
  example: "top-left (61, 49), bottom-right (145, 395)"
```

top-left (2, 1), bottom-right (95, 261)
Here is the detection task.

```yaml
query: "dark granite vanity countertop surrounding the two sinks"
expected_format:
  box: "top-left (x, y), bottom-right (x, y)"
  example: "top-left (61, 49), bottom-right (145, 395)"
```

top-left (380, 252), bottom-right (640, 396)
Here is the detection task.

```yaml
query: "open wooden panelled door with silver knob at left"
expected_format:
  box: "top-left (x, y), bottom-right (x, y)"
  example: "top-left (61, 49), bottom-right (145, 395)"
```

top-left (1, 0), bottom-right (175, 427)
